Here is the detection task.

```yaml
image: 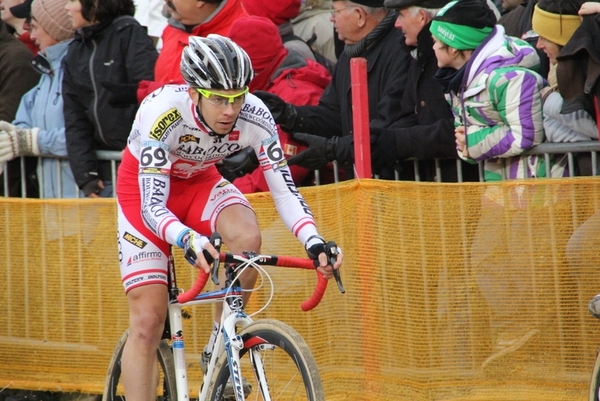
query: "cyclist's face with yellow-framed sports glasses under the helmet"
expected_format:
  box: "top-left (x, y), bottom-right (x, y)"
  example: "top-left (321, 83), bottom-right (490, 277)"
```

top-left (189, 88), bottom-right (245, 135)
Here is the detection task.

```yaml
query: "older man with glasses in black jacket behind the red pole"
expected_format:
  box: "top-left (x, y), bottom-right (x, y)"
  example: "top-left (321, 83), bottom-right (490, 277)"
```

top-left (256, 0), bottom-right (410, 178)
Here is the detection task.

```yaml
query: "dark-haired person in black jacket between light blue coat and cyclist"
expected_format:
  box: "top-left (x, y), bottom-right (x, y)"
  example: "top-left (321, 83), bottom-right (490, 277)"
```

top-left (63, 0), bottom-right (157, 197)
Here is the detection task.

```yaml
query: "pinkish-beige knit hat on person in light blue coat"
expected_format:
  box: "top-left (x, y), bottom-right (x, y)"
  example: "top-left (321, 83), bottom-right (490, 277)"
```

top-left (31, 0), bottom-right (74, 42)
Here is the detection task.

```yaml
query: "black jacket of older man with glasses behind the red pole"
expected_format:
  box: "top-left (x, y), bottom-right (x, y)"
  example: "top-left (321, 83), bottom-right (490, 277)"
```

top-left (294, 12), bottom-right (410, 138)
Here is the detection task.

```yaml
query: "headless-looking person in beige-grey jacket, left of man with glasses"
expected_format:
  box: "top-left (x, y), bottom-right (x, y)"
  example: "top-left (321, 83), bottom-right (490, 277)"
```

top-left (292, 0), bottom-right (337, 63)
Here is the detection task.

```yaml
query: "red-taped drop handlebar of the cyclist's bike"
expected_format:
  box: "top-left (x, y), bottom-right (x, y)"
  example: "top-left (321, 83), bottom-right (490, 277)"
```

top-left (177, 252), bottom-right (327, 312)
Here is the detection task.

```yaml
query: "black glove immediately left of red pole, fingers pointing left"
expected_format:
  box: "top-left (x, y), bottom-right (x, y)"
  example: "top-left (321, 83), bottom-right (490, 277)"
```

top-left (288, 132), bottom-right (354, 170)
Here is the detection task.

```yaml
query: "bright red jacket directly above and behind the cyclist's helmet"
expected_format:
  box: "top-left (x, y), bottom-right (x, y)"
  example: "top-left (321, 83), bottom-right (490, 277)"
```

top-left (154, 0), bottom-right (248, 83)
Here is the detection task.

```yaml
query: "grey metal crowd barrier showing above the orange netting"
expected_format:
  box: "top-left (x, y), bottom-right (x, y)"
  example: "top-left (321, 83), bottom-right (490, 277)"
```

top-left (0, 140), bottom-right (600, 198)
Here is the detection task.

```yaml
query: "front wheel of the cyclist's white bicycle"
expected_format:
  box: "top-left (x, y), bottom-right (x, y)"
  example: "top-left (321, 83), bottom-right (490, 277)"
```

top-left (208, 319), bottom-right (325, 401)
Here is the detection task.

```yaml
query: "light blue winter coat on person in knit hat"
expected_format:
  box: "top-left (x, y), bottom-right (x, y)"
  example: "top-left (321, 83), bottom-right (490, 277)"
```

top-left (13, 40), bottom-right (79, 198)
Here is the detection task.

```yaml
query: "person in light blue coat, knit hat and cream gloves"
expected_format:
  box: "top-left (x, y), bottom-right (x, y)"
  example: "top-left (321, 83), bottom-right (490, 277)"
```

top-left (0, 0), bottom-right (78, 198)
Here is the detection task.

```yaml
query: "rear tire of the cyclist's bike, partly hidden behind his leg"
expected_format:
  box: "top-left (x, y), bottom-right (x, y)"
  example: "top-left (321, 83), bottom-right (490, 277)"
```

top-left (102, 330), bottom-right (177, 401)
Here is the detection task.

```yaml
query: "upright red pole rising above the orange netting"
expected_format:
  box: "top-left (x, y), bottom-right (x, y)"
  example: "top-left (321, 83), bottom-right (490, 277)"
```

top-left (350, 57), bottom-right (371, 178)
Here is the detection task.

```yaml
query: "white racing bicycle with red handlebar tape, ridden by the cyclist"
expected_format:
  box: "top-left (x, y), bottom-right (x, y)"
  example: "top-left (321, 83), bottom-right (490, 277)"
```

top-left (102, 234), bottom-right (345, 401)
